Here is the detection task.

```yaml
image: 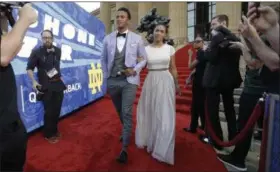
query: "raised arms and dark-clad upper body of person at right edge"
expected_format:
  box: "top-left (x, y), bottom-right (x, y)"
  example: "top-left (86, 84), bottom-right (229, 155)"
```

top-left (239, 3), bottom-right (280, 94)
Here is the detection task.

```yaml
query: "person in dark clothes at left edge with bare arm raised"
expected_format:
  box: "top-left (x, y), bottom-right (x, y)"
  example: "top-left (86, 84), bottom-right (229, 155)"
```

top-left (0, 4), bottom-right (37, 171)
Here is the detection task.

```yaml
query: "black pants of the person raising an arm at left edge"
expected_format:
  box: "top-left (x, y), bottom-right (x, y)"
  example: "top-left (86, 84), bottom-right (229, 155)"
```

top-left (0, 121), bottom-right (27, 172)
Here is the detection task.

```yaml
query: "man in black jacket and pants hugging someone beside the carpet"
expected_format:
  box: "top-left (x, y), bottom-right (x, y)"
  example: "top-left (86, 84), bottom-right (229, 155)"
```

top-left (202, 15), bottom-right (242, 149)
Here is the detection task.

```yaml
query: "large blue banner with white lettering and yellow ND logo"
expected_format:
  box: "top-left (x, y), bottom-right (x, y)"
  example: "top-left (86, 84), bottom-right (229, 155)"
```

top-left (12, 2), bottom-right (106, 132)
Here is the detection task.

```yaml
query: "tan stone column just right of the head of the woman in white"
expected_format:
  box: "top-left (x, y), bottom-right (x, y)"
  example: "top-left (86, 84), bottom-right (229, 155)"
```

top-left (169, 2), bottom-right (188, 47)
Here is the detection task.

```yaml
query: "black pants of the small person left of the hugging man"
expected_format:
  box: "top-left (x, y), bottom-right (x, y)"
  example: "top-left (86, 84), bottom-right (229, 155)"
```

top-left (190, 83), bottom-right (205, 130)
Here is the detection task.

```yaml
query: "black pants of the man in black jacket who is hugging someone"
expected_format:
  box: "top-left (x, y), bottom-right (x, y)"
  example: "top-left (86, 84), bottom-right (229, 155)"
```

top-left (206, 88), bottom-right (237, 144)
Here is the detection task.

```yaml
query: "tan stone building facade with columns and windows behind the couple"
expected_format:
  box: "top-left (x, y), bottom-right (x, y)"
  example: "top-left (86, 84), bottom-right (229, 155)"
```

top-left (92, 2), bottom-right (279, 77)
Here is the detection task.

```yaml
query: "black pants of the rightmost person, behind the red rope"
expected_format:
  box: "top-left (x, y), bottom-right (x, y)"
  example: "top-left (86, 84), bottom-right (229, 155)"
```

top-left (231, 93), bottom-right (262, 163)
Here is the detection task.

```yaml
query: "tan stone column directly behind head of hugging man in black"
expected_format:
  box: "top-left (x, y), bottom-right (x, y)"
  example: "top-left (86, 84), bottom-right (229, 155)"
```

top-left (216, 2), bottom-right (242, 33)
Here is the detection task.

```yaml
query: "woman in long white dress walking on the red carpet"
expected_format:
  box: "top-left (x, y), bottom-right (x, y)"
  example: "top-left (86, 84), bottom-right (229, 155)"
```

top-left (135, 25), bottom-right (180, 165)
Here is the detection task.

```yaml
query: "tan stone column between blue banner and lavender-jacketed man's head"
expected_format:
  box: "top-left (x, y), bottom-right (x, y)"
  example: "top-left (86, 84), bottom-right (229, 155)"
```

top-left (100, 2), bottom-right (111, 34)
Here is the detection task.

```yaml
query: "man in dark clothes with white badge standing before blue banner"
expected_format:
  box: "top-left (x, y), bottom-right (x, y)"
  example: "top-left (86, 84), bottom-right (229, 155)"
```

top-left (27, 30), bottom-right (66, 143)
